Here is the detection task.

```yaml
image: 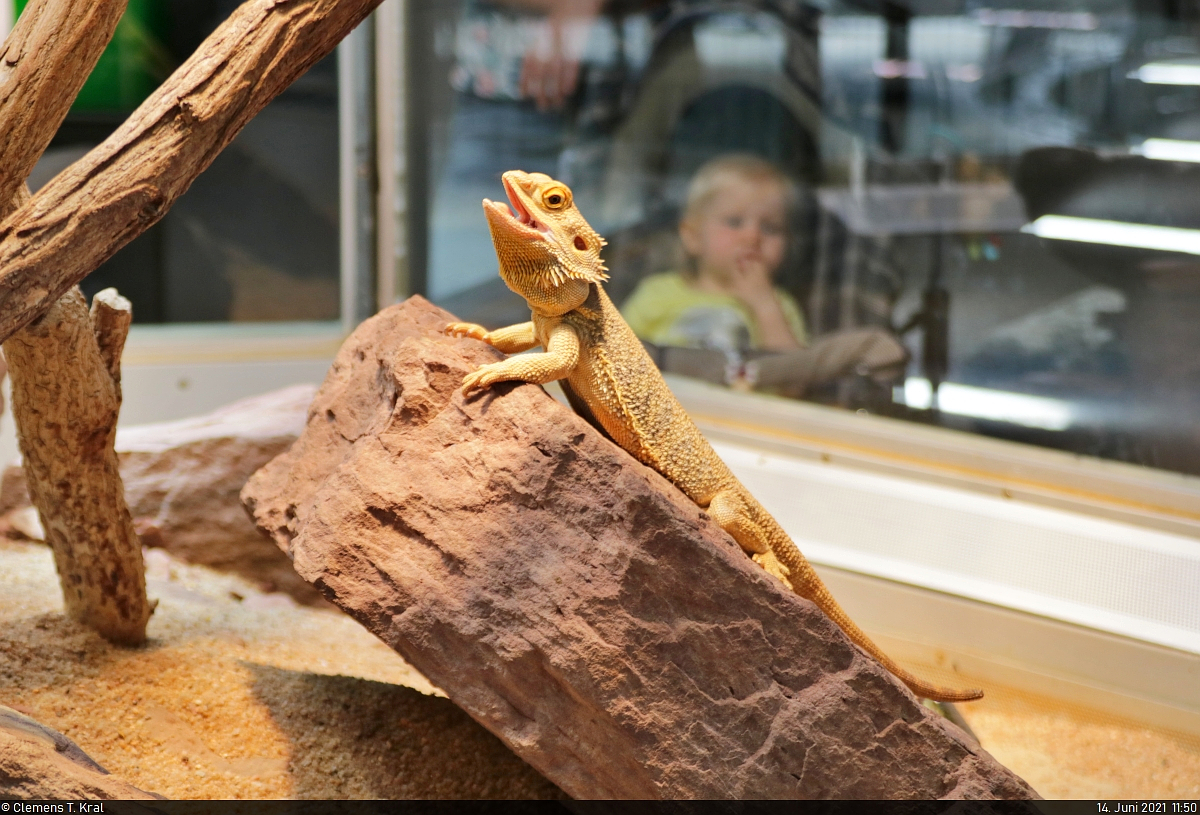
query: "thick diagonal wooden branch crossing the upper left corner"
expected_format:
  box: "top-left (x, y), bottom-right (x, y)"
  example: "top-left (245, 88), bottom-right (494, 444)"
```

top-left (0, 0), bottom-right (380, 338)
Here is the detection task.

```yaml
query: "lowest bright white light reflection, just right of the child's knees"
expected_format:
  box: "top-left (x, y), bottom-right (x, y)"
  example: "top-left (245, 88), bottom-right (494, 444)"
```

top-left (895, 377), bottom-right (1072, 430)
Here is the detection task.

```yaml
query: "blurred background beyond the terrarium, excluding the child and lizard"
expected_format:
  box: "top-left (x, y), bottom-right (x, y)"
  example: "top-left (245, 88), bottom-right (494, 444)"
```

top-left (11, 0), bottom-right (1200, 482)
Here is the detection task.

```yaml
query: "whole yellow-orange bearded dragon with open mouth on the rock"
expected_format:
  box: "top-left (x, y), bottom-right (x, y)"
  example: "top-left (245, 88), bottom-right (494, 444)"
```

top-left (446, 170), bottom-right (983, 702)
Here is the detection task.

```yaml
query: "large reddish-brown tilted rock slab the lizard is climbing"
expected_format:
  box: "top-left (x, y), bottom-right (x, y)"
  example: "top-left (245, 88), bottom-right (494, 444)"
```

top-left (242, 298), bottom-right (1036, 798)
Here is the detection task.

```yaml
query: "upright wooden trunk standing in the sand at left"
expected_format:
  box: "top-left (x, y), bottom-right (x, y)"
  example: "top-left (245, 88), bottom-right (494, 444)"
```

top-left (5, 287), bottom-right (151, 645)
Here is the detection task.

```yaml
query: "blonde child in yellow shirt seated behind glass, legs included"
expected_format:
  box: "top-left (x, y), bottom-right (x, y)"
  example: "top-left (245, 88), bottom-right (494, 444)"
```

top-left (622, 154), bottom-right (908, 396)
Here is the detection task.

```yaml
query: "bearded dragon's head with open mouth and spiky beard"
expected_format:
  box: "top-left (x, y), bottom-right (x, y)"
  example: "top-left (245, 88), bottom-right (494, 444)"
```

top-left (484, 170), bottom-right (608, 314)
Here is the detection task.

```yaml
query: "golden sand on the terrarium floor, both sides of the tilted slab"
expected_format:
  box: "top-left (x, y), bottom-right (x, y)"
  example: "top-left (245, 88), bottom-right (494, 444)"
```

top-left (0, 541), bottom-right (1200, 798)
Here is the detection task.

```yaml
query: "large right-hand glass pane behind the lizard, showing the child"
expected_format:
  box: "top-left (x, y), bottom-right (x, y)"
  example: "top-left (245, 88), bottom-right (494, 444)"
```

top-left (408, 0), bottom-right (1200, 482)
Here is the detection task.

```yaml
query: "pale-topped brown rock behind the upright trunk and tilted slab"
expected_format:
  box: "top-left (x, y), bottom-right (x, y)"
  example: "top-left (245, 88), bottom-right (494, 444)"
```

top-left (0, 385), bottom-right (320, 603)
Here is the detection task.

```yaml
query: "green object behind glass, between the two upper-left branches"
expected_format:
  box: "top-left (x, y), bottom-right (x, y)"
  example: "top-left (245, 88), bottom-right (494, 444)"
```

top-left (14, 0), bottom-right (175, 113)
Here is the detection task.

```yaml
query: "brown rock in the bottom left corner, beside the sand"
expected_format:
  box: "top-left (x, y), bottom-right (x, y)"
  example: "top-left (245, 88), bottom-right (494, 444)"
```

top-left (0, 705), bottom-right (161, 809)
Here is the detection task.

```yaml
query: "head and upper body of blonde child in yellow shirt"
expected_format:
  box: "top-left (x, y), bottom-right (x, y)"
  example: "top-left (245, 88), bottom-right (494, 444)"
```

top-left (622, 154), bottom-right (806, 352)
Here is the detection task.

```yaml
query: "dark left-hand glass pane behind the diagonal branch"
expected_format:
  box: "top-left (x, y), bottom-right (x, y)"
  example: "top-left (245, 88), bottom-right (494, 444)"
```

top-left (16, 0), bottom-right (338, 323)
